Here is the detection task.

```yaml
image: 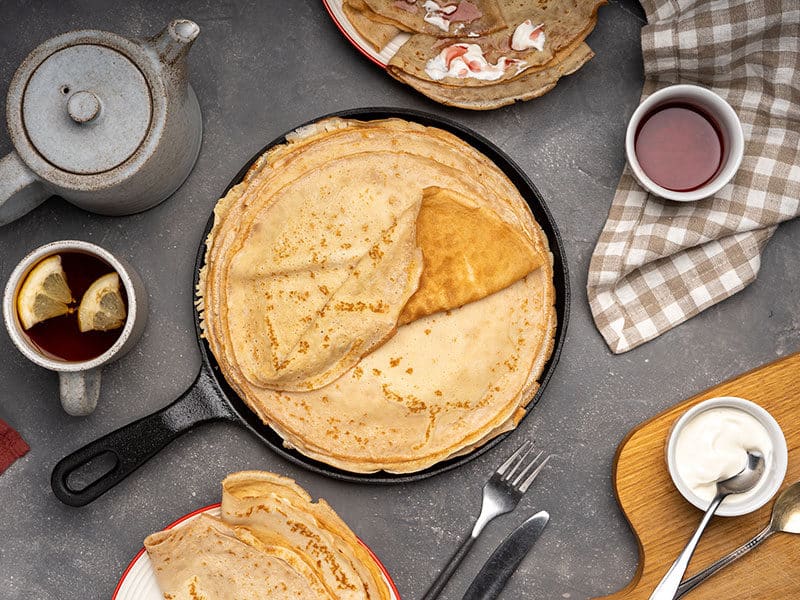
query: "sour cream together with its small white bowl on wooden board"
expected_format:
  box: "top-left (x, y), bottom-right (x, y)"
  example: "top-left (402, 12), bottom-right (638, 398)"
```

top-left (667, 396), bottom-right (788, 517)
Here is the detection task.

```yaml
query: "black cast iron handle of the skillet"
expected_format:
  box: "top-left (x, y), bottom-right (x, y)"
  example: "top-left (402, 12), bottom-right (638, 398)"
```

top-left (50, 366), bottom-right (235, 506)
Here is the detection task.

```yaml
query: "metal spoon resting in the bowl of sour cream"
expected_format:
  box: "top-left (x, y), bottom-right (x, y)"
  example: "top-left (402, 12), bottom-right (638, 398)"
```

top-left (650, 450), bottom-right (764, 600)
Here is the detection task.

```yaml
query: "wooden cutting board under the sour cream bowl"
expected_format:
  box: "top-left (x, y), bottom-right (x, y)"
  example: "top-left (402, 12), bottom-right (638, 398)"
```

top-left (605, 353), bottom-right (800, 600)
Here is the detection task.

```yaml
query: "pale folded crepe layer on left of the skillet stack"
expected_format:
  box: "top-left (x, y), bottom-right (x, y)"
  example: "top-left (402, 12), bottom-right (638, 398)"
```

top-left (220, 176), bottom-right (422, 391)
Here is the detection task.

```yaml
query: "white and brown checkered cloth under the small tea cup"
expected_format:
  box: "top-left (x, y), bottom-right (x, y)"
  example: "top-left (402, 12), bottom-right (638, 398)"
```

top-left (587, 0), bottom-right (800, 353)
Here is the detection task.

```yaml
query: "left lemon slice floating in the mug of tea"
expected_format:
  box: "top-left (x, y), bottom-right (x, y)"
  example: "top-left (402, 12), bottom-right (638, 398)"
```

top-left (17, 254), bottom-right (73, 329)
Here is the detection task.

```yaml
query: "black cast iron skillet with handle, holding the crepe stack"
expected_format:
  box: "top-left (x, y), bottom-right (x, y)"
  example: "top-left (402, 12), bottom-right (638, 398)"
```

top-left (51, 108), bottom-right (569, 506)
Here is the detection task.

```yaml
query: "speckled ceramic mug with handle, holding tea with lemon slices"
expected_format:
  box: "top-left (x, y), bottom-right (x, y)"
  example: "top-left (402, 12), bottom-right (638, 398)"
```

top-left (3, 240), bottom-right (147, 416)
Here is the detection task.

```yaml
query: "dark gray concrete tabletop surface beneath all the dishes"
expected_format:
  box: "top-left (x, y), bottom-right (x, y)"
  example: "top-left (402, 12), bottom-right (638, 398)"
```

top-left (0, 0), bottom-right (800, 600)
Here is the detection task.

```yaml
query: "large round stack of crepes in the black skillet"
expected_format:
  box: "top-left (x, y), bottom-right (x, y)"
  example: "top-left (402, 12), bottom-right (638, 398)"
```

top-left (198, 118), bottom-right (556, 473)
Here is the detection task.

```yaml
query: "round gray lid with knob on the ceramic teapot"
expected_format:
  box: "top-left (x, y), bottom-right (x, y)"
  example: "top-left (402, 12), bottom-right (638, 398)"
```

top-left (21, 43), bottom-right (153, 175)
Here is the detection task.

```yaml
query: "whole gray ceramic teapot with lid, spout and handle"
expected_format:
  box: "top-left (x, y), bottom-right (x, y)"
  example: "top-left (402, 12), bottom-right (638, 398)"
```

top-left (0, 19), bottom-right (202, 225)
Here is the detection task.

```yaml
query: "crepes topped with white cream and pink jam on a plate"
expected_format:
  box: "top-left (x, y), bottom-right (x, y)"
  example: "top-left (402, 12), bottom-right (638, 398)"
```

top-left (343, 0), bottom-right (606, 110)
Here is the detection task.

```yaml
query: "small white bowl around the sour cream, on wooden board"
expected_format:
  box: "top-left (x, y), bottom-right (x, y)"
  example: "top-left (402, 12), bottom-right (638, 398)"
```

top-left (667, 396), bottom-right (789, 517)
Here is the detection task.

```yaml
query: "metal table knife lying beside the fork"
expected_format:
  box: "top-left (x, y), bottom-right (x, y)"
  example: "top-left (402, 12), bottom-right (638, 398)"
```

top-left (464, 511), bottom-right (550, 600)
